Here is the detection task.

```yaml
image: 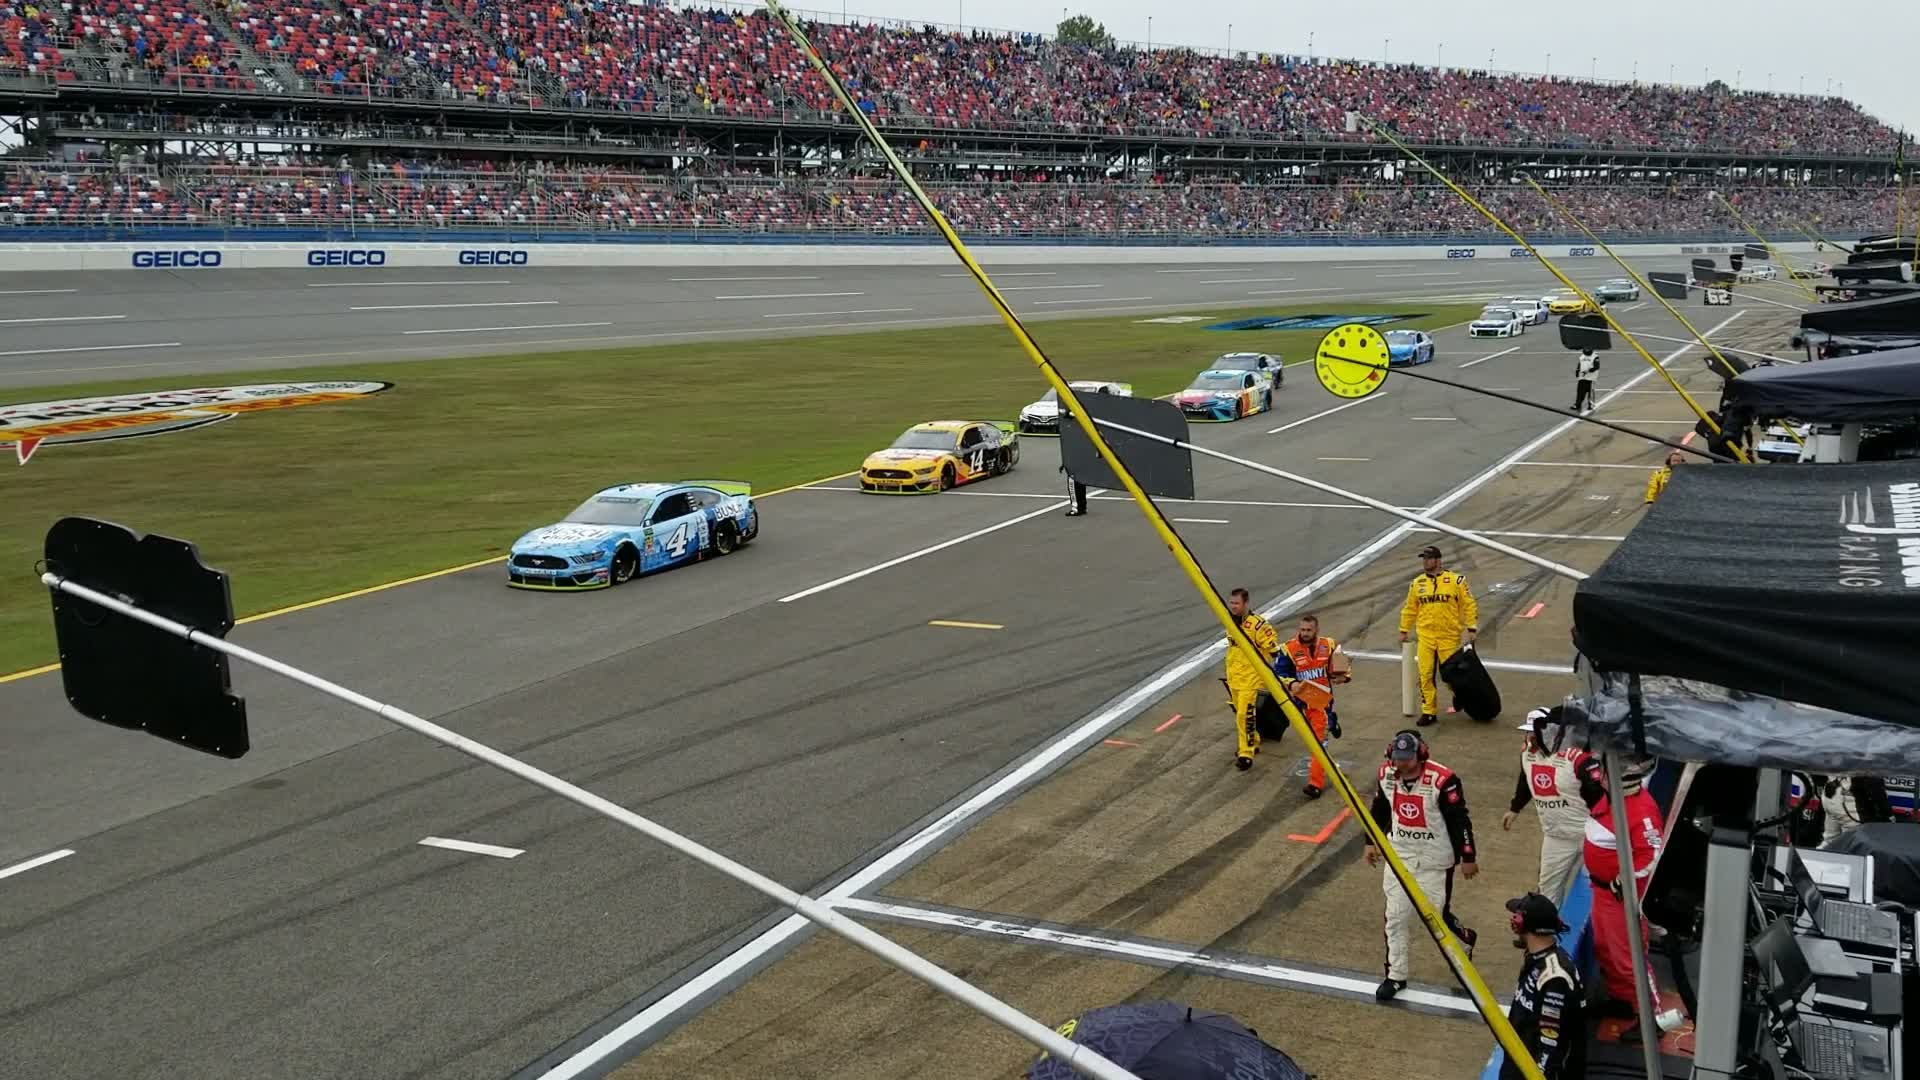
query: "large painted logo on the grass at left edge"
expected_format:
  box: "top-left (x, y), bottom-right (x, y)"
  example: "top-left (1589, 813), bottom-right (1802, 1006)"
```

top-left (0, 382), bottom-right (394, 465)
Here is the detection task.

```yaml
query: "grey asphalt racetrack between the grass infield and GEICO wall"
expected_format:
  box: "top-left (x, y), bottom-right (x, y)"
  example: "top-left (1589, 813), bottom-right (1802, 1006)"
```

top-left (0, 252), bottom-right (1658, 386)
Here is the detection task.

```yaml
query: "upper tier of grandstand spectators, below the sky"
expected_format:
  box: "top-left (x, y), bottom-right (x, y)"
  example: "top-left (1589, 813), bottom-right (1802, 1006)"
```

top-left (0, 0), bottom-right (1895, 156)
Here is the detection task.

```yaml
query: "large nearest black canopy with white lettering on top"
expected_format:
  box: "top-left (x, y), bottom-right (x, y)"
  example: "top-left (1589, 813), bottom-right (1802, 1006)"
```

top-left (1572, 459), bottom-right (1920, 773)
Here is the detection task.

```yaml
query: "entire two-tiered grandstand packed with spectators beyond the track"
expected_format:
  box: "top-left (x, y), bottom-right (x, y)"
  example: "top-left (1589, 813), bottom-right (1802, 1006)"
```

top-left (0, 0), bottom-right (1895, 242)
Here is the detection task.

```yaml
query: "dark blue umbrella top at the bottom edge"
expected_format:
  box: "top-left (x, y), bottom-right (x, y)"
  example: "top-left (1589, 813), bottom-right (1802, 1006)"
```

top-left (1027, 1001), bottom-right (1313, 1080)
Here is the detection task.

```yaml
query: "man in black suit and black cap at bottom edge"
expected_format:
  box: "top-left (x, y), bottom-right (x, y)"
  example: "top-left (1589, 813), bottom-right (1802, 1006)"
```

top-left (1500, 892), bottom-right (1586, 1080)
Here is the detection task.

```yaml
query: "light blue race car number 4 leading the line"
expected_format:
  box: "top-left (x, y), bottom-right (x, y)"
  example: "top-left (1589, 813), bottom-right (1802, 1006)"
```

top-left (507, 480), bottom-right (760, 590)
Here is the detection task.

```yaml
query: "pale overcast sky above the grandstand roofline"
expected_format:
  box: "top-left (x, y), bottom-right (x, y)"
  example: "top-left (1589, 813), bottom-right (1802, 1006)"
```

top-left (821, 0), bottom-right (1920, 143)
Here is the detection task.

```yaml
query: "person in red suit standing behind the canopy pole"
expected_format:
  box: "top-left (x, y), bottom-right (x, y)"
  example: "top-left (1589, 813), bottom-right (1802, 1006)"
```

top-left (1580, 759), bottom-right (1665, 1022)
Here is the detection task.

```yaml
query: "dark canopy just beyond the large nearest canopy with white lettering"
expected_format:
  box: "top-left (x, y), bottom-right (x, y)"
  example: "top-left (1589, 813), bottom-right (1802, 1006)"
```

top-left (1720, 348), bottom-right (1920, 427)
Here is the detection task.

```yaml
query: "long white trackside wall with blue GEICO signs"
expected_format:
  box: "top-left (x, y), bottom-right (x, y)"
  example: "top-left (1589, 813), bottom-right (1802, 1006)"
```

top-left (0, 240), bottom-right (1814, 273)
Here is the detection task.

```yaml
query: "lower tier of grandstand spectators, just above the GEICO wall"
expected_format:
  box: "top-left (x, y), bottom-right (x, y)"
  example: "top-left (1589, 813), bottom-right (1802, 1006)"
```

top-left (0, 160), bottom-right (1893, 236)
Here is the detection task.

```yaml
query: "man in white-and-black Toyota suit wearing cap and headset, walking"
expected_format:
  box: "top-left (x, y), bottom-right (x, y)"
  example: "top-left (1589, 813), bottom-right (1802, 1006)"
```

top-left (1367, 730), bottom-right (1480, 1001)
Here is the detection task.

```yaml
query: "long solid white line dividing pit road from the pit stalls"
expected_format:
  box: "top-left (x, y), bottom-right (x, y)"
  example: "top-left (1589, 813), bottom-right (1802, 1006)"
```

top-left (545, 311), bottom-right (1745, 1080)
